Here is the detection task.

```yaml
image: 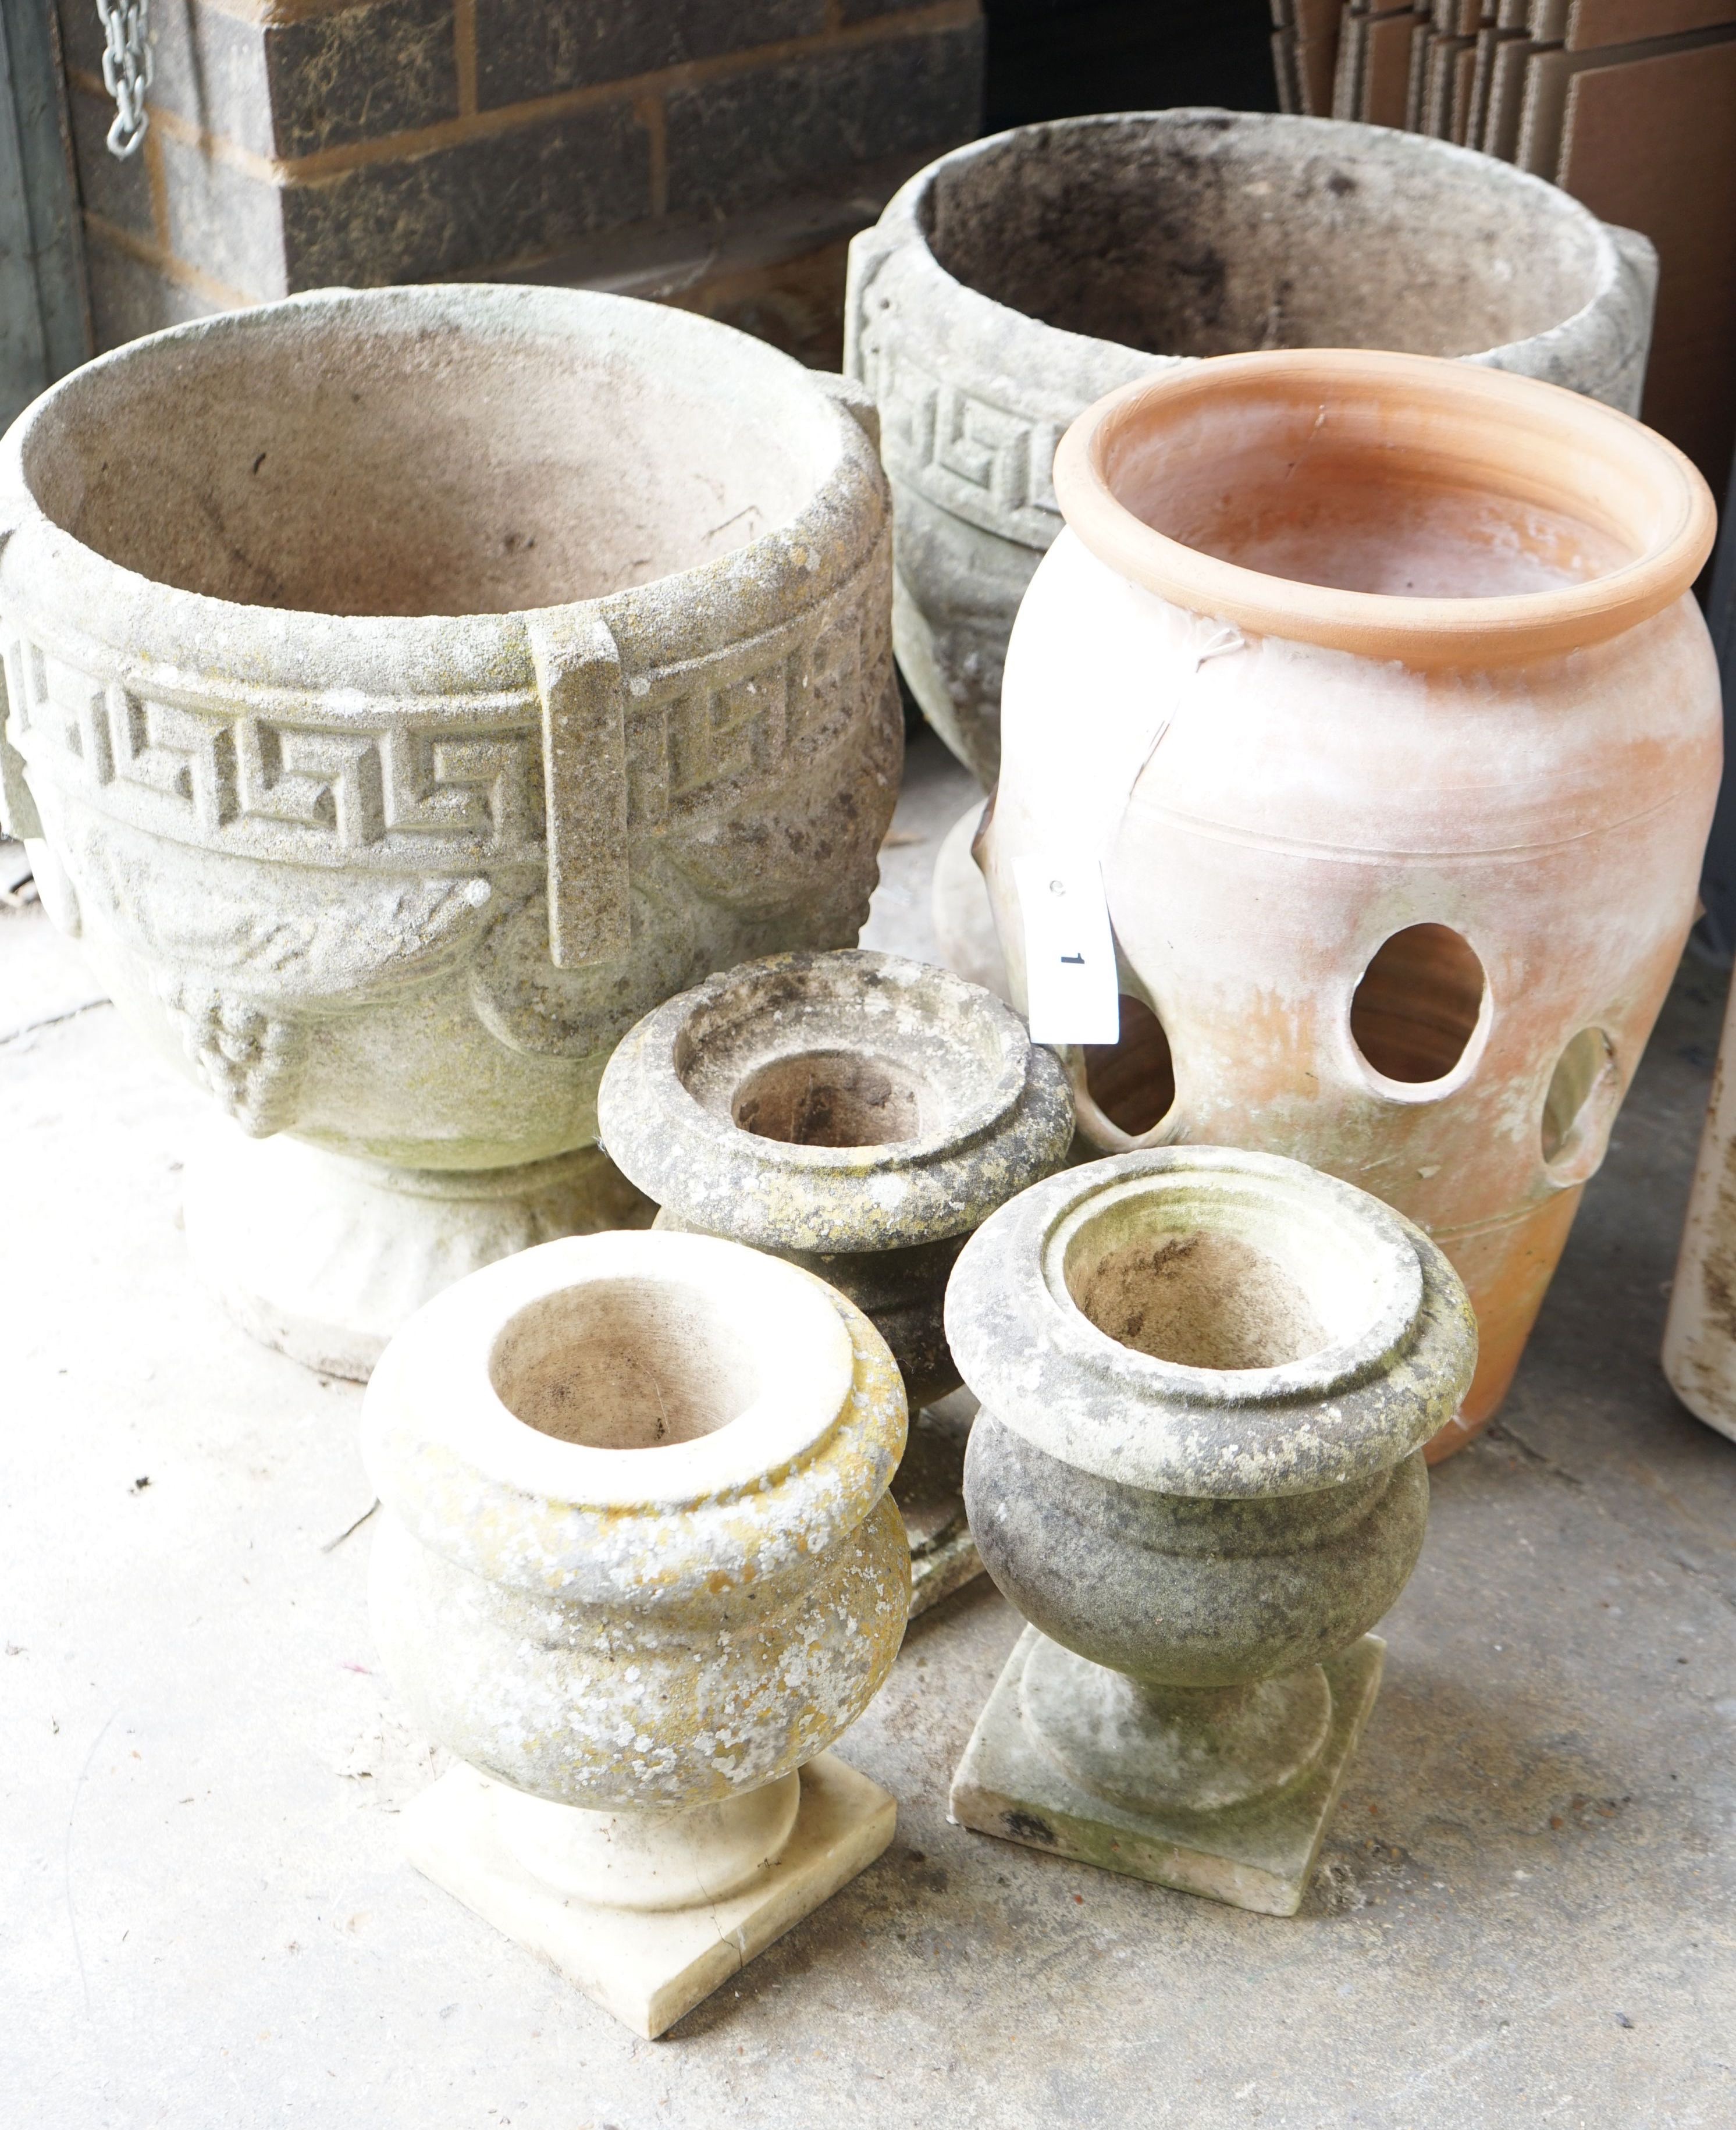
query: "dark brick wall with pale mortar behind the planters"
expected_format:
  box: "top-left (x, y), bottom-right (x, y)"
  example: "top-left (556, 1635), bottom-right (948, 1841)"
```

top-left (58, 0), bottom-right (982, 347)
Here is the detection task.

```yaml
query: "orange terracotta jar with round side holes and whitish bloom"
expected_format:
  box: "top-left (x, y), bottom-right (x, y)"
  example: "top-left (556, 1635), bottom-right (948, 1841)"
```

top-left (980, 351), bottom-right (1721, 1457)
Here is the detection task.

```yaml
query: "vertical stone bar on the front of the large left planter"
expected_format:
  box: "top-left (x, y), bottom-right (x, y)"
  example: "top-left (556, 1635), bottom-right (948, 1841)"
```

top-left (524, 607), bottom-right (632, 969)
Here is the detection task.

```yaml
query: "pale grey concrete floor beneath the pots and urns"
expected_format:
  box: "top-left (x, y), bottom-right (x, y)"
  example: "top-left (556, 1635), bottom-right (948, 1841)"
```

top-left (0, 741), bottom-right (1736, 2130)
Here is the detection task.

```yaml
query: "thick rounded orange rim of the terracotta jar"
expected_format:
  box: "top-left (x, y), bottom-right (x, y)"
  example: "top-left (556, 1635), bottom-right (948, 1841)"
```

top-left (1054, 347), bottom-right (1717, 667)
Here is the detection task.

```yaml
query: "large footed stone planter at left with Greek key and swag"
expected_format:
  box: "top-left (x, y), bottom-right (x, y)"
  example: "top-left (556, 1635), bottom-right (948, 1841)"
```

top-left (0, 287), bottom-right (901, 1376)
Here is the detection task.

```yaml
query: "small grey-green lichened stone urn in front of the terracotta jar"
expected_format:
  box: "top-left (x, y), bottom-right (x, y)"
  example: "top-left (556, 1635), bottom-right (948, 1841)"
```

top-left (946, 1146), bottom-right (1476, 1915)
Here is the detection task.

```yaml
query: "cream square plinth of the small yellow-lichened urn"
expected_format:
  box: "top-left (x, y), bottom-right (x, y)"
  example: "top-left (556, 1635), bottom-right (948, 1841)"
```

top-left (403, 1753), bottom-right (899, 2040)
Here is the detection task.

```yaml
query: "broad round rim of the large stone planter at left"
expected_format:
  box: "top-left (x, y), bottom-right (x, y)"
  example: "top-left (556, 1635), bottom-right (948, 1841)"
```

top-left (0, 283), bottom-right (886, 698)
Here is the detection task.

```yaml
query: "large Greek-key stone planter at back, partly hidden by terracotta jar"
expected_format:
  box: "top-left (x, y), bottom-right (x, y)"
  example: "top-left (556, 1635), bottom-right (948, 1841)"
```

top-left (846, 111), bottom-right (1657, 784)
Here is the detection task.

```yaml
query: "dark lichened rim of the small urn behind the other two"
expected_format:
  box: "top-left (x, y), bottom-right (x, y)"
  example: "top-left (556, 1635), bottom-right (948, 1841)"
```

top-left (596, 948), bottom-right (1073, 1253)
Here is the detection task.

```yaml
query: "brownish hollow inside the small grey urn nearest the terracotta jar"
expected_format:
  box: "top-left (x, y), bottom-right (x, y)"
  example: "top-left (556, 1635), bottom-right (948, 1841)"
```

top-left (1067, 1231), bottom-right (1327, 1367)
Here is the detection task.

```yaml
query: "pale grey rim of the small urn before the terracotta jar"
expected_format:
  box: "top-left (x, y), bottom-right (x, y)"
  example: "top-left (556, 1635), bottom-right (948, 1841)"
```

top-left (946, 1146), bottom-right (1476, 1499)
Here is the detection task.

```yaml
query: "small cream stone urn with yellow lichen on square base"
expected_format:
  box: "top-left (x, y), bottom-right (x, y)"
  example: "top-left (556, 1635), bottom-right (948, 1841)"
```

top-left (362, 1233), bottom-right (909, 2036)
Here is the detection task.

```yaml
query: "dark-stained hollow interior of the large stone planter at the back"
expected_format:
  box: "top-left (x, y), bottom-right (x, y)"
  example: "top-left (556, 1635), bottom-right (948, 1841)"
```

top-left (922, 113), bottom-right (1600, 355)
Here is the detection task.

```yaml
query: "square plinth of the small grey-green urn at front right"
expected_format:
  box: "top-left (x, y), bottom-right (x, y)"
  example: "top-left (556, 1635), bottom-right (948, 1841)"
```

top-left (952, 1627), bottom-right (1387, 1915)
